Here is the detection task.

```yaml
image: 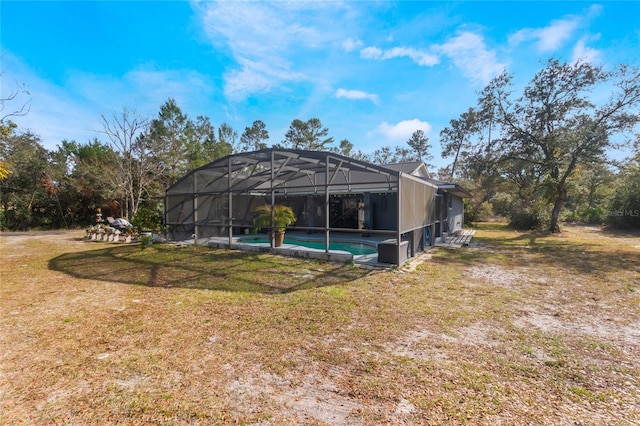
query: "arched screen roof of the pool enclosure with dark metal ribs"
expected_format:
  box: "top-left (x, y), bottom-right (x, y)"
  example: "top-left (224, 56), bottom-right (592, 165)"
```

top-left (166, 148), bottom-right (432, 195)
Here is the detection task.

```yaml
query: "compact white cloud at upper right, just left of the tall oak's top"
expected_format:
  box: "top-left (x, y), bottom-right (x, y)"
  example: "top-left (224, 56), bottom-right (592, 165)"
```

top-left (436, 32), bottom-right (506, 83)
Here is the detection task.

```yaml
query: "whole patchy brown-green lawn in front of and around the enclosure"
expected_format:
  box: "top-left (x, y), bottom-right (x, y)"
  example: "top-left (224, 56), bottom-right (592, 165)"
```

top-left (0, 224), bottom-right (640, 425)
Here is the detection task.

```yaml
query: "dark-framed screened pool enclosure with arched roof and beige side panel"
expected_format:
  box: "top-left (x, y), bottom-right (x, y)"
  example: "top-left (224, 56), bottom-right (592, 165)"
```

top-left (164, 148), bottom-right (438, 264)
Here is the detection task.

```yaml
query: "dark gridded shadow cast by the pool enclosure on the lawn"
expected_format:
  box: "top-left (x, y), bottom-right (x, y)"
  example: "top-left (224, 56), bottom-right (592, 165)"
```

top-left (49, 244), bottom-right (369, 294)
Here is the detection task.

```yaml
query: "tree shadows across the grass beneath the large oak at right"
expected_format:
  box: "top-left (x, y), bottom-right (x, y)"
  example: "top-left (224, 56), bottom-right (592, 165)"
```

top-left (440, 223), bottom-right (640, 277)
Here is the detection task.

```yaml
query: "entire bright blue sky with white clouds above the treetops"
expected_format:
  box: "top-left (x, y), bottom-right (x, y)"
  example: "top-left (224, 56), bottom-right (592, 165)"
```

top-left (0, 0), bottom-right (640, 170)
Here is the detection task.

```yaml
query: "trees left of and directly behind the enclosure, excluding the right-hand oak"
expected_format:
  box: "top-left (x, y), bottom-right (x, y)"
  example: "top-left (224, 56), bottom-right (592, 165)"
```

top-left (0, 98), bottom-right (430, 230)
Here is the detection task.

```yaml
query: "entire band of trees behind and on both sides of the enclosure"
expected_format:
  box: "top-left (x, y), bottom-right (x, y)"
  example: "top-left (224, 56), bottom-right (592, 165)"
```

top-left (0, 59), bottom-right (640, 232)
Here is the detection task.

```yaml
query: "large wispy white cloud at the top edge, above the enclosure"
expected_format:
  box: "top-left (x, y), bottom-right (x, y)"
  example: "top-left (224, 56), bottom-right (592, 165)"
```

top-left (194, 1), bottom-right (361, 101)
